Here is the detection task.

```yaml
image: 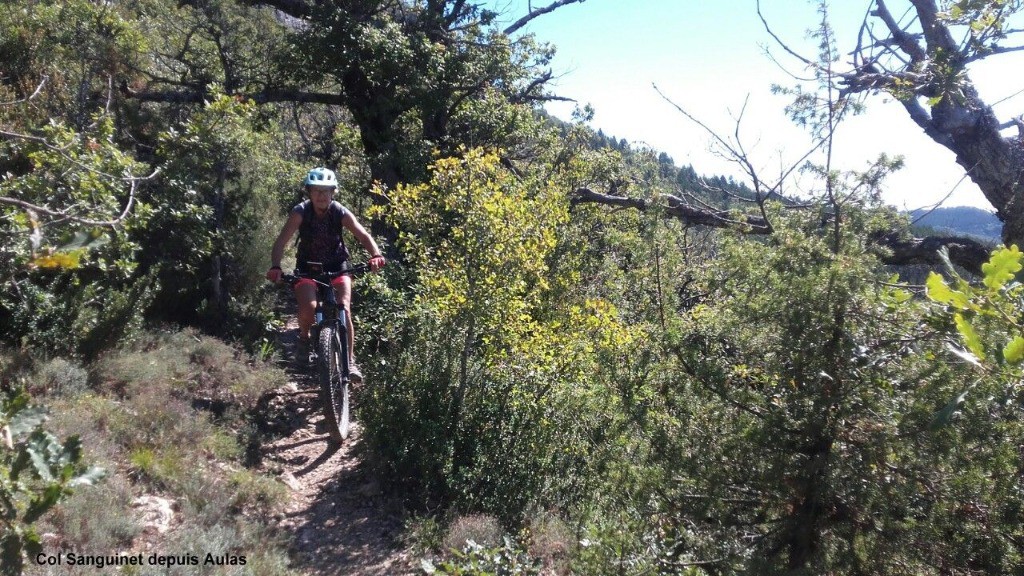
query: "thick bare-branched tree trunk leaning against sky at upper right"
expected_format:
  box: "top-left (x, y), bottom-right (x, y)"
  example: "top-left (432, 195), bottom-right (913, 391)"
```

top-left (841, 0), bottom-right (1024, 245)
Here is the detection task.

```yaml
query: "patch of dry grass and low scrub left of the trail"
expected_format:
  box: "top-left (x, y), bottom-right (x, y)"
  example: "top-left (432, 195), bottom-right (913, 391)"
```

top-left (20, 331), bottom-right (299, 576)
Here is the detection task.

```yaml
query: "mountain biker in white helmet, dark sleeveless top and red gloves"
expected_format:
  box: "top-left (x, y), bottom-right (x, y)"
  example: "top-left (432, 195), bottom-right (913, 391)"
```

top-left (266, 168), bottom-right (387, 381)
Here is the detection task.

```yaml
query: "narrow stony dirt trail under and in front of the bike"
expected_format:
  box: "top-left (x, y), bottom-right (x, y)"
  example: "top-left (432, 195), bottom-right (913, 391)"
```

top-left (261, 321), bottom-right (420, 576)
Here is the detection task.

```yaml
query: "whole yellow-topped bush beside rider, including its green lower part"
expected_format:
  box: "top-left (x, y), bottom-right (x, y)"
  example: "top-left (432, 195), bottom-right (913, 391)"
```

top-left (374, 149), bottom-right (633, 518)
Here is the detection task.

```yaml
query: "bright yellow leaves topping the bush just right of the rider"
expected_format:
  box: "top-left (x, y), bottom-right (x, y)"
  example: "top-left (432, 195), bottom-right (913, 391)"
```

top-left (378, 145), bottom-right (565, 349)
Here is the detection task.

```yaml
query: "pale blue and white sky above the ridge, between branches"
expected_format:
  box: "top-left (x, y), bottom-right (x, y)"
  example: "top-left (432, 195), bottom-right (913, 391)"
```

top-left (494, 0), bottom-right (1024, 209)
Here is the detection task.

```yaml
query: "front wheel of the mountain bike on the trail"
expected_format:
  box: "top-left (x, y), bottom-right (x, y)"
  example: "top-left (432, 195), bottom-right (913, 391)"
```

top-left (316, 318), bottom-right (349, 443)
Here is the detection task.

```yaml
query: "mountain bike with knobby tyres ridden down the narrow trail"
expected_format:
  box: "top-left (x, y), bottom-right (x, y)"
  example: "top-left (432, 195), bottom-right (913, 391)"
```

top-left (281, 264), bottom-right (370, 443)
